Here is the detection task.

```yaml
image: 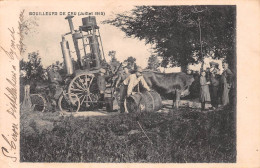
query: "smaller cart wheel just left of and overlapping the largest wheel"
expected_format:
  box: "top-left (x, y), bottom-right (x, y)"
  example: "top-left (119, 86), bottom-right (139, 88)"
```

top-left (58, 93), bottom-right (80, 112)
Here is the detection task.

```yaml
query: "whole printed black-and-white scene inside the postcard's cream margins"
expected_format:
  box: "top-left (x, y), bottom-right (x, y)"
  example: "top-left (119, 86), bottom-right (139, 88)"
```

top-left (20, 5), bottom-right (236, 163)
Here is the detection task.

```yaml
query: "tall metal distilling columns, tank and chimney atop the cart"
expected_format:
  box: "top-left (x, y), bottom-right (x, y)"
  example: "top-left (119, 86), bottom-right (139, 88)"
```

top-left (61, 15), bottom-right (105, 75)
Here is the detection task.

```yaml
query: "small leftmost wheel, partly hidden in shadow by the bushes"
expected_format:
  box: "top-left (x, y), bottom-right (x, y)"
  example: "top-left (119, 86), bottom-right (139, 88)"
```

top-left (30, 94), bottom-right (47, 112)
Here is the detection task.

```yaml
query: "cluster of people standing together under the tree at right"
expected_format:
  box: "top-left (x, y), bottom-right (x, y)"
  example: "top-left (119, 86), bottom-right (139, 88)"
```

top-left (200, 62), bottom-right (234, 110)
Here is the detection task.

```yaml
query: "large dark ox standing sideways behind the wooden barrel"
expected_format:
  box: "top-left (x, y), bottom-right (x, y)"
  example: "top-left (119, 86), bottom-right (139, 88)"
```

top-left (143, 71), bottom-right (194, 108)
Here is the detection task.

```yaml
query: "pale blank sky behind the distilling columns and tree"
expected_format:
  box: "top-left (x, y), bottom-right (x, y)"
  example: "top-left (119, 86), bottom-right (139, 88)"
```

top-left (24, 5), bottom-right (222, 73)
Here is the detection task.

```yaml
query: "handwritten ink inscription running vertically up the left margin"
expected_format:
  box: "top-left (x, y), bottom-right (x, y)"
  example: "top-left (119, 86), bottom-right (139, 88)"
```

top-left (0, 27), bottom-right (21, 162)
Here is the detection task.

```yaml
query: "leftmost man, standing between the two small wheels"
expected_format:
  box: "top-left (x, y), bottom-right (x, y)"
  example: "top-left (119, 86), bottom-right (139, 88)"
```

top-left (49, 65), bottom-right (62, 111)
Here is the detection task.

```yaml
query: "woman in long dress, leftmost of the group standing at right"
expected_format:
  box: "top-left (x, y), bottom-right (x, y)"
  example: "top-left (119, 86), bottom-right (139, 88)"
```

top-left (200, 71), bottom-right (210, 110)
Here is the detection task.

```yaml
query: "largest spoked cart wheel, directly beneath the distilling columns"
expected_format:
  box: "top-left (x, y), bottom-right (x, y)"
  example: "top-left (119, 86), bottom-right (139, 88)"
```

top-left (68, 73), bottom-right (100, 110)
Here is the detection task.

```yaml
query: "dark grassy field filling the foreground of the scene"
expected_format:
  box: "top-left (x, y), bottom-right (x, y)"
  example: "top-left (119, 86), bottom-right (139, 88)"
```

top-left (20, 108), bottom-right (236, 163)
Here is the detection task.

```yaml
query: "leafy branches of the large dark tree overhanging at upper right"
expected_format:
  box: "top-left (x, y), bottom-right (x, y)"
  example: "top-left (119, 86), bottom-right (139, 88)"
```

top-left (103, 6), bottom-right (236, 71)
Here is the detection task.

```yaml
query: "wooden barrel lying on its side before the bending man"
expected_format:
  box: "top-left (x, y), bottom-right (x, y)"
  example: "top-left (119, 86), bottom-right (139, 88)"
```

top-left (126, 91), bottom-right (162, 113)
